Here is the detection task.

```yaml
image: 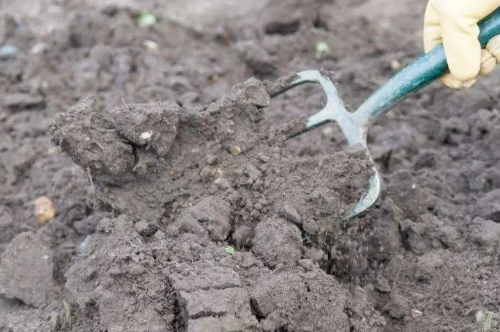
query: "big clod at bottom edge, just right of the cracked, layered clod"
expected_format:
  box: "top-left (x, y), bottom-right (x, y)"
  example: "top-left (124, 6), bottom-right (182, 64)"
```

top-left (251, 270), bottom-right (349, 332)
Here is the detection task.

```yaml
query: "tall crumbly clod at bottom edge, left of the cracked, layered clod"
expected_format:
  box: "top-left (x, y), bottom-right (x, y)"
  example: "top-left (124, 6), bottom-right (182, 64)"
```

top-left (66, 216), bottom-right (174, 332)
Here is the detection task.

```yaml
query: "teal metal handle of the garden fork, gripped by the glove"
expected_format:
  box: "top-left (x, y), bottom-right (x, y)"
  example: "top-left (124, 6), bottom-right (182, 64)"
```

top-left (353, 8), bottom-right (500, 126)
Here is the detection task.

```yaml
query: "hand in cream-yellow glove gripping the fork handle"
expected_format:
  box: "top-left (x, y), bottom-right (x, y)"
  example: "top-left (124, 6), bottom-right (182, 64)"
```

top-left (424, 0), bottom-right (500, 89)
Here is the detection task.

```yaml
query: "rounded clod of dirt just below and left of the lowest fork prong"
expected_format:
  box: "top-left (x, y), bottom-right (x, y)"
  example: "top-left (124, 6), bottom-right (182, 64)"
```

top-left (252, 218), bottom-right (302, 268)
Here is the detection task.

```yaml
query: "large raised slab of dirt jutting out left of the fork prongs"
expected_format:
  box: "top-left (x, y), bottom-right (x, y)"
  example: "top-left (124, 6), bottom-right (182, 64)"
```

top-left (52, 79), bottom-right (284, 219)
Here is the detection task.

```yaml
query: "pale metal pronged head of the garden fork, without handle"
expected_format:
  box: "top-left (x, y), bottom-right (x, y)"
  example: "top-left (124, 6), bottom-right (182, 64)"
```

top-left (271, 70), bottom-right (381, 219)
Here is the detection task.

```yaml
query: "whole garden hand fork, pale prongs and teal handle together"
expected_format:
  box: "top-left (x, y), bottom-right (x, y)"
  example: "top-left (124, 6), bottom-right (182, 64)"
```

top-left (271, 4), bottom-right (500, 218)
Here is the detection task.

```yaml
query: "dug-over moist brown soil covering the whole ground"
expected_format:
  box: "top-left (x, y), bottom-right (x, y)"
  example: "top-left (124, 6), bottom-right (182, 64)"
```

top-left (0, 0), bottom-right (500, 332)
